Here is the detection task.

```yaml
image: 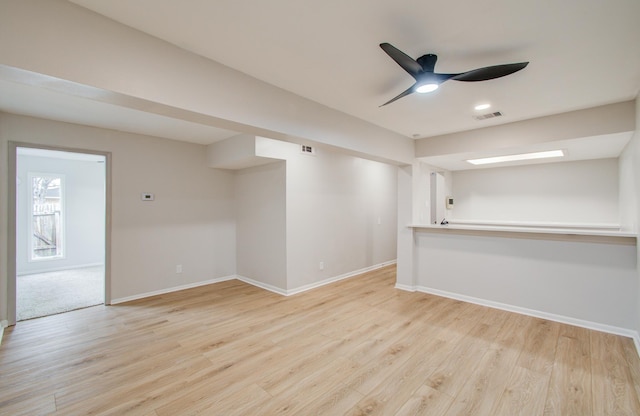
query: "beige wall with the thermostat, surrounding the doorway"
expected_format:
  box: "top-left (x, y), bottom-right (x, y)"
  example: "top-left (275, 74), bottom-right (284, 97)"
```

top-left (0, 113), bottom-right (236, 317)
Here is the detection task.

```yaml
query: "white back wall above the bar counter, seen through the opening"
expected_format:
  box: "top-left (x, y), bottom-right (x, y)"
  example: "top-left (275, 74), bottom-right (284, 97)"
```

top-left (450, 159), bottom-right (619, 224)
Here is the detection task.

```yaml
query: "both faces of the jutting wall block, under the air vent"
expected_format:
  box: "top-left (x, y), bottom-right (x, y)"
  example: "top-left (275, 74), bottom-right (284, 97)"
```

top-left (236, 138), bottom-right (398, 293)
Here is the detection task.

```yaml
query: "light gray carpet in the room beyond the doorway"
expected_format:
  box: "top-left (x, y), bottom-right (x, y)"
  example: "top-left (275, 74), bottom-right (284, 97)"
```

top-left (16, 266), bottom-right (104, 321)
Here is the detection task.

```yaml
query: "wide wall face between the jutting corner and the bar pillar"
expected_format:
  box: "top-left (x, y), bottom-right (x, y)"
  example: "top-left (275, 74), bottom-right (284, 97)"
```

top-left (287, 149), bottom-right (398, 290)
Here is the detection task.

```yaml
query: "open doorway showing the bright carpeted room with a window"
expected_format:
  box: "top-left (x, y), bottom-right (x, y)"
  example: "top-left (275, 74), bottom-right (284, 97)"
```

top-left (9, 145), bottom-right (109, 323)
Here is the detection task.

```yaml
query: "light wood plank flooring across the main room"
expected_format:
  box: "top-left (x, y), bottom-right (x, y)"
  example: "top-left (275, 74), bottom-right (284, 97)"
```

top-left (0, 266), bottom-right (640, 416)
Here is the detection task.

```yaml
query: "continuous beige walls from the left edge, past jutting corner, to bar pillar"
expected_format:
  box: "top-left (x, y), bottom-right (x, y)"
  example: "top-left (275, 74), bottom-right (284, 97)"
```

top-left (0, 113), bottom-right (397, 319)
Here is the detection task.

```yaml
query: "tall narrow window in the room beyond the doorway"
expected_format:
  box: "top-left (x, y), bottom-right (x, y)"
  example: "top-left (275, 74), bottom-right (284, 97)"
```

top-left (29, 172), bottom-right (64, 261)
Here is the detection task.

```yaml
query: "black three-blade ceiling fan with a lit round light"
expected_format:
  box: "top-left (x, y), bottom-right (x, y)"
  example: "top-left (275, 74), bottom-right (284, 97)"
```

top-left (380, 42), bottom-right (529, 107)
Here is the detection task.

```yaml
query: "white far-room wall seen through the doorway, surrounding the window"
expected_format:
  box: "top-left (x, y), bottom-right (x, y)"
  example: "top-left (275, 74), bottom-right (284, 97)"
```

top-left (16, 155), bottom-right (105, 274)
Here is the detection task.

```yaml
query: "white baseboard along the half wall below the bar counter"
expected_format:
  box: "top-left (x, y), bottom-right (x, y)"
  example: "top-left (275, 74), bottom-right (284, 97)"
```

top-left (396, 284), bottom-right (640, 356)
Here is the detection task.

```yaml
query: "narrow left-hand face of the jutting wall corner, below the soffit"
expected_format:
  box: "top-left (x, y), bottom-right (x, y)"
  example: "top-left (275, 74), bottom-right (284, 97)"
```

top-left (235, 162), bottom-right (287, 291)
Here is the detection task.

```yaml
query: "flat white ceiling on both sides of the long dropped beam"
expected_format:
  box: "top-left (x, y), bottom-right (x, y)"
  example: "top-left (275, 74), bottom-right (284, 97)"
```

top-left (0, 0), bottom-right (640, 168)
